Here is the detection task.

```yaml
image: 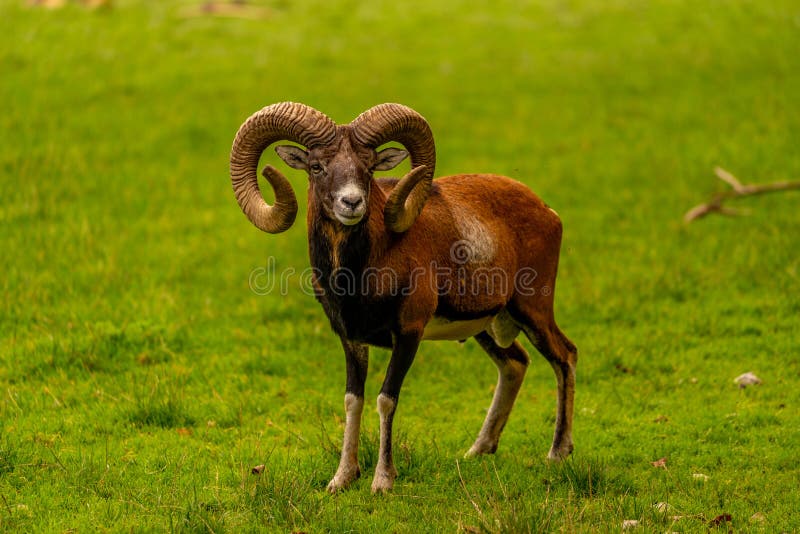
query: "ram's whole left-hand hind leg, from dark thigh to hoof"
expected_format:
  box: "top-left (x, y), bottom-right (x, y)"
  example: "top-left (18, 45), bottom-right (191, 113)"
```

top-left (466, 332), bottom-right (530, 457)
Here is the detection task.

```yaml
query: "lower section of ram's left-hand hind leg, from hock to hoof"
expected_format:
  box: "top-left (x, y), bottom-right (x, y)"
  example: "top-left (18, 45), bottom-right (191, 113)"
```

top-left (466, 360), bottom-right (527, 457)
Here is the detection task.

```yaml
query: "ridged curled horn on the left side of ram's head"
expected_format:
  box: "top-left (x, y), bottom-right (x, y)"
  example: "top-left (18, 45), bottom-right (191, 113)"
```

top-left (231, 102), bottom-right (336, 234)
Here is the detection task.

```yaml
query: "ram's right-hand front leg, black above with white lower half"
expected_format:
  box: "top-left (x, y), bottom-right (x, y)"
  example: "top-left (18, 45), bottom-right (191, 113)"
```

top-left (372, 328), bottom-right (422, 493)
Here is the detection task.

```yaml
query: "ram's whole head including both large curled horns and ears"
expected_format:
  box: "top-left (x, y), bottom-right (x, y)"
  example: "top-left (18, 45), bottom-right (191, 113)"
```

top-left (231, 102), bottom-right (436, 233)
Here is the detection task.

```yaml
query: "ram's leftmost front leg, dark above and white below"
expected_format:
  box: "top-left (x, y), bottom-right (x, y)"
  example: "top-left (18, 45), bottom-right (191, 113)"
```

top-left (328, 337), bottom-right (369, 493)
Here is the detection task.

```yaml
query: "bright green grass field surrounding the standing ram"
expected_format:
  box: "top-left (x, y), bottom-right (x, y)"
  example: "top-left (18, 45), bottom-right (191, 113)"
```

top-left (0, 0), bottom-right (800, 533)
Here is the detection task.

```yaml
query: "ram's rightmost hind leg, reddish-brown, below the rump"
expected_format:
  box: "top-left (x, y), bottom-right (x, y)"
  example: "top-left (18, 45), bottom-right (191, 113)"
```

top-left (514, 312), bottom-right (578, 461)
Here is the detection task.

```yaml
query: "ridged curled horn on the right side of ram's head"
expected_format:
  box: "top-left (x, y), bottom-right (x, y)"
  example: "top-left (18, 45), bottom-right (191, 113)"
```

top-left (350, 104), bottom-right (436, 232)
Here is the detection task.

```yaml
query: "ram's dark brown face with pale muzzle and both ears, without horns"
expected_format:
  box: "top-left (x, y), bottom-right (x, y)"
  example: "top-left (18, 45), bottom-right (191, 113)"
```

top-left (275, 130), bottom-right (408, 226)
